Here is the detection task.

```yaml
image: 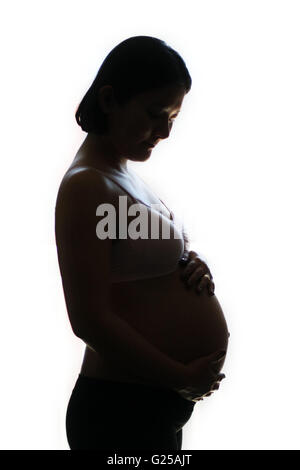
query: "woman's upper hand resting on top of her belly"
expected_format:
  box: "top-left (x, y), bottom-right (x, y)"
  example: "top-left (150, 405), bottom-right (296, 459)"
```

top-left (180, 251), bottom-right (215, 295)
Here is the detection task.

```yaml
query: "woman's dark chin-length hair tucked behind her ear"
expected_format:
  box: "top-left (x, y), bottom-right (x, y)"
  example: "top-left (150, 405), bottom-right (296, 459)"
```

top-left (75, 36), bottom-right (192, 134)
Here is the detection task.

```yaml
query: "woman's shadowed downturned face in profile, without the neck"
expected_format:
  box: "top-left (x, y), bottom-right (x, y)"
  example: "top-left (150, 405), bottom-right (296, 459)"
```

top-left (104, 85), bottom-right (185, 161)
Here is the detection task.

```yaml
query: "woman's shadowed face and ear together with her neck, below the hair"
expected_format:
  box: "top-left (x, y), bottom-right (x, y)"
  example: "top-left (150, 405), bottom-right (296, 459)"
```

top-left (75, 85), bottom-right (186, 173)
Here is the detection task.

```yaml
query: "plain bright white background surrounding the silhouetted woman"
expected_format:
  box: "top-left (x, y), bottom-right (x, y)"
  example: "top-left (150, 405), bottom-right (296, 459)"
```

top-left (0, 0), bottom-right (300, 450)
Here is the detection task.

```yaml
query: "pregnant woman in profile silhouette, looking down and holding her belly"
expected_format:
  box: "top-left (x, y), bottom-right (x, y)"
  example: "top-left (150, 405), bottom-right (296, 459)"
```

top-left (55, 36), bottom-right (229, 450)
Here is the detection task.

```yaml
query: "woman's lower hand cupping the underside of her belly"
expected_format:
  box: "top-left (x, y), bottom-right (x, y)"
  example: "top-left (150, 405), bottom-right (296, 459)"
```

top-left (177, 351), bottom-right (226, 400)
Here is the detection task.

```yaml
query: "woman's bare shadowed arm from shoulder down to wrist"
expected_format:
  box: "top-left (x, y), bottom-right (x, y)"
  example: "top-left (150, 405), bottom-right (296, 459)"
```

top-left (55, 170), bottom-right (189, 388)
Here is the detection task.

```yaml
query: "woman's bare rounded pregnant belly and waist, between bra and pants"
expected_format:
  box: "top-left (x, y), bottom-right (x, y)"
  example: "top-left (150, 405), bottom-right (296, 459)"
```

top-left (81, 265), bottom-right (229, 383)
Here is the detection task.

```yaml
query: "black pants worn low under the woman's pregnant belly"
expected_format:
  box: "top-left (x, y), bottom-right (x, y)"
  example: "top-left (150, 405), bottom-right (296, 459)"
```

top-left (66, 374), bottom-right (195, 450)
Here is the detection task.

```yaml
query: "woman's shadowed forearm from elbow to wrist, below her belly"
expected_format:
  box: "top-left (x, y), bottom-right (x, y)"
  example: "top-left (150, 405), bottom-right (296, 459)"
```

top-left (77, 312), bottom-right (189, 388)
